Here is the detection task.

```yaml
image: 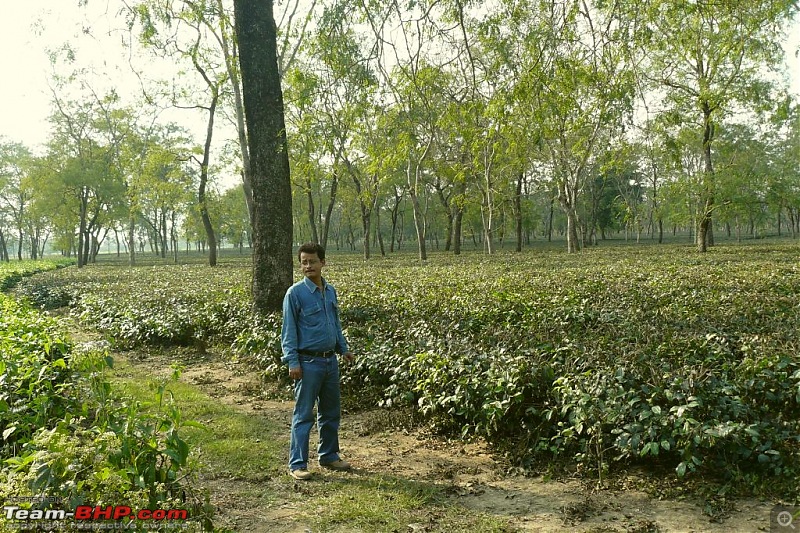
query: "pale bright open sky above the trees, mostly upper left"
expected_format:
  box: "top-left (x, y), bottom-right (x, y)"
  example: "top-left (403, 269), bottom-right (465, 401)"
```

top-left (0, 0), bottom-right (800, 152)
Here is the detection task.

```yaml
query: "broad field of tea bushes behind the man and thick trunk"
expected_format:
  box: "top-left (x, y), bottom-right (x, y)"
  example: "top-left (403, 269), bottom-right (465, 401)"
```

top-left (15, 244), bottom-right (800, 494)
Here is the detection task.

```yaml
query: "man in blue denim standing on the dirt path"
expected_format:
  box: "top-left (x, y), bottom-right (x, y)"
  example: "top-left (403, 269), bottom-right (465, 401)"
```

top-left (281, 243), bottom-right (353, 481)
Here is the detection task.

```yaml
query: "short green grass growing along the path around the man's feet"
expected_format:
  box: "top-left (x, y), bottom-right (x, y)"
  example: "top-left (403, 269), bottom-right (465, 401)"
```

top-left (106, 355), bottom-right (510, 533)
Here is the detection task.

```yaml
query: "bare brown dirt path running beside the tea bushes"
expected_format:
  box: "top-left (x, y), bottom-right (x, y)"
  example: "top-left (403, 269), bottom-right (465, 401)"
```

top-left (122, 350), bottom-right (774, 533)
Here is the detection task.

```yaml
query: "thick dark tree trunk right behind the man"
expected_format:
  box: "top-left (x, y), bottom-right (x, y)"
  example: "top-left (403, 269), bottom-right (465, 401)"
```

top-left (233, 0), bottom-right (293, 314)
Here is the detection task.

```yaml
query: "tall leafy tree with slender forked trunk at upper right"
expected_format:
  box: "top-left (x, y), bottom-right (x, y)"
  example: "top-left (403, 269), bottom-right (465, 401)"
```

top-left (624, 0), bottom-right (797, 252)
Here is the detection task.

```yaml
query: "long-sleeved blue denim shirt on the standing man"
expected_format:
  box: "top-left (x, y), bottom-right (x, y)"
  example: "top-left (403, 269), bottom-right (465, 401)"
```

top-left (281, 277), bottom-right (349, 368)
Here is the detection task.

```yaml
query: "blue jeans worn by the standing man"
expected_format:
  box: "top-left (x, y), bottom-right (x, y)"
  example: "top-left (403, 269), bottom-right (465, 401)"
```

top-left (289, 355), bottom-right (341, 470)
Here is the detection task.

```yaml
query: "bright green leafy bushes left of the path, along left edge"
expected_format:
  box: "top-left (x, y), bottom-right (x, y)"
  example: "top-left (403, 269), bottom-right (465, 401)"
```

top-left (0, 261), bottom-right (207, 529)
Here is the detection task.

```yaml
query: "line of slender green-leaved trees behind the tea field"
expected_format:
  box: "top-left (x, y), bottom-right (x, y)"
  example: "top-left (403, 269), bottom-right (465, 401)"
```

top-left (0, 0), bottom-right (800, 265)
